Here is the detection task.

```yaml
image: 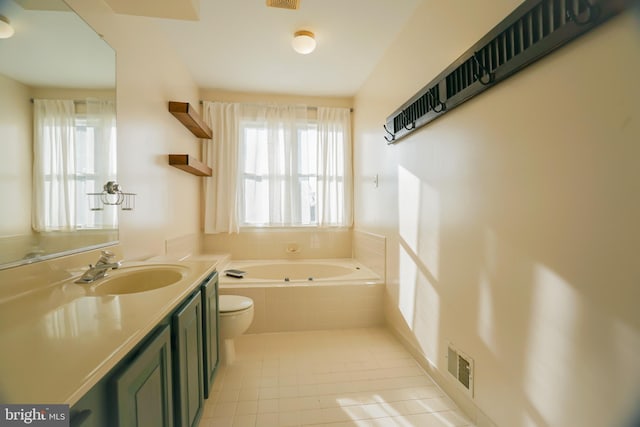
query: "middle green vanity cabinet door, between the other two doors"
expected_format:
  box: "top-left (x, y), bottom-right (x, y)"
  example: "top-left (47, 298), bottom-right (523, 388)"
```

top-left (172, 291), bottom-right (204, 427)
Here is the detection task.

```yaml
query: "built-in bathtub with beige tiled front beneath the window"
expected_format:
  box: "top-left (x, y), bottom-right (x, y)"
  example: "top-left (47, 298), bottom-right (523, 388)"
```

top-left (218, 259), bottom-right (384, 333)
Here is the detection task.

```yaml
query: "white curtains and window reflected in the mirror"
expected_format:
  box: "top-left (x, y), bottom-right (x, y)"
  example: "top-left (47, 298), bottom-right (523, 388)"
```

top-left (32, 99), bottom-right (117, 232)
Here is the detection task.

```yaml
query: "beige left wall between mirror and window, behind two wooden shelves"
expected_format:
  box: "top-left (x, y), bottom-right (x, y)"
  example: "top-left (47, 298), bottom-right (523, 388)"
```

top-left (69, 0), bottom-right (200, 259)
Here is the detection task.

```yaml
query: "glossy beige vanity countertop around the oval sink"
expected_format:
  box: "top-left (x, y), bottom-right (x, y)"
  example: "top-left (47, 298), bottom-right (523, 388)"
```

top-left (0, 257), bottom-right (225, 405)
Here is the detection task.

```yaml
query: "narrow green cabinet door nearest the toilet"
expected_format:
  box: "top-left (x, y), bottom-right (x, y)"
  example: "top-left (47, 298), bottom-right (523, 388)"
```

top-left (202, 273), bottom-right (219, 399)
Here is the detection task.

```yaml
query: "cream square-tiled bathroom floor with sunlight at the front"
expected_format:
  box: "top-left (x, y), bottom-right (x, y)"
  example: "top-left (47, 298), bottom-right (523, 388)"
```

top-left (200, 329), bottom-right (472, 427)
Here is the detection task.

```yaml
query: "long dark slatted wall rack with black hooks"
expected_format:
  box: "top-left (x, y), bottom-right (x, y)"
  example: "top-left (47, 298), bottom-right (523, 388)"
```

top-left (384, 0), bottom-right (634, 144)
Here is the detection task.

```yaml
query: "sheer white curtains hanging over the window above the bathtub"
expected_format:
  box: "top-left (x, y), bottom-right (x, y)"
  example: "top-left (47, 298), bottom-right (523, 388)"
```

top-left (203, 102), bottom-right (353, 233)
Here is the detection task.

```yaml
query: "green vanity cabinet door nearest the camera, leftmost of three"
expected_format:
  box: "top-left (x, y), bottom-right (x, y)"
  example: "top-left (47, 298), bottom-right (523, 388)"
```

top-left (114, 325), bottom-right (173, 427)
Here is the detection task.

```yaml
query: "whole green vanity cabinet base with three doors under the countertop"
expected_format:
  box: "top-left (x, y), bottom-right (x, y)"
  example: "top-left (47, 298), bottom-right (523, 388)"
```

top-left (70, 271), bottom-right (219, 427)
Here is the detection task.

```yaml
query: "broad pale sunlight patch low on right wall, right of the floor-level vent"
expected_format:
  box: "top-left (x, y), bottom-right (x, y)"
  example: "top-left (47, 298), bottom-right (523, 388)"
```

top-left (514, 265), bottom-right (580, 425)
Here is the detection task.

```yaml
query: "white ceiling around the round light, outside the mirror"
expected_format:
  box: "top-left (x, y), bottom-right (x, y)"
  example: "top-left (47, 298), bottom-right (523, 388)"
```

top-left (152, 0), bottom-right (423, 96)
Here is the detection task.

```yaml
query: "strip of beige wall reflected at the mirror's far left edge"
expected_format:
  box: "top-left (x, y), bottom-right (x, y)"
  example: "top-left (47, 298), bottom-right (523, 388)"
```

top-left (0, 75), bottom-right (33, 236)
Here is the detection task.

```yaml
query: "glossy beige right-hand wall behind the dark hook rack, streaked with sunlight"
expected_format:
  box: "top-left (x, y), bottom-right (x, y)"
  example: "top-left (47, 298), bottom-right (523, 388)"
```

top-left (354, 0), bottom-right (640, 427)
